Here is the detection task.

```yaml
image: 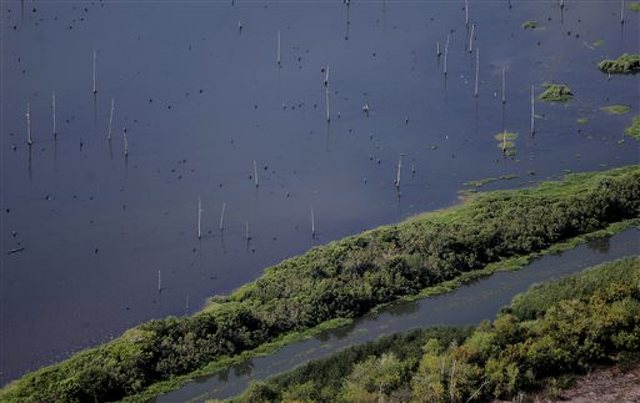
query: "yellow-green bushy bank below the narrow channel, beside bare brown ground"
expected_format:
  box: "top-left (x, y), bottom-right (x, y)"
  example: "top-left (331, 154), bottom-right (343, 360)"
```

top-left (232, 256), bottom-right (640, 402)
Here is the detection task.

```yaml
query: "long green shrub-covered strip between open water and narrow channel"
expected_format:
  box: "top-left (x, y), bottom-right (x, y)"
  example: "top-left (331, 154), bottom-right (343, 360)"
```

top-left (0, 166), bottom-right (640, 401)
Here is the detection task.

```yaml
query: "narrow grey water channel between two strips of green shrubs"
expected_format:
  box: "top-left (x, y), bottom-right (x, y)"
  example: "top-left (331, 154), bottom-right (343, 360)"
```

top-left (155, 229), bottom-right (640, 403)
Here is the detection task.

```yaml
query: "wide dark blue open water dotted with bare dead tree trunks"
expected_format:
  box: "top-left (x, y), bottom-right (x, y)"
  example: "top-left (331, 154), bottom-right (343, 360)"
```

top-left (0, 0), bottom-right (640, 384)
